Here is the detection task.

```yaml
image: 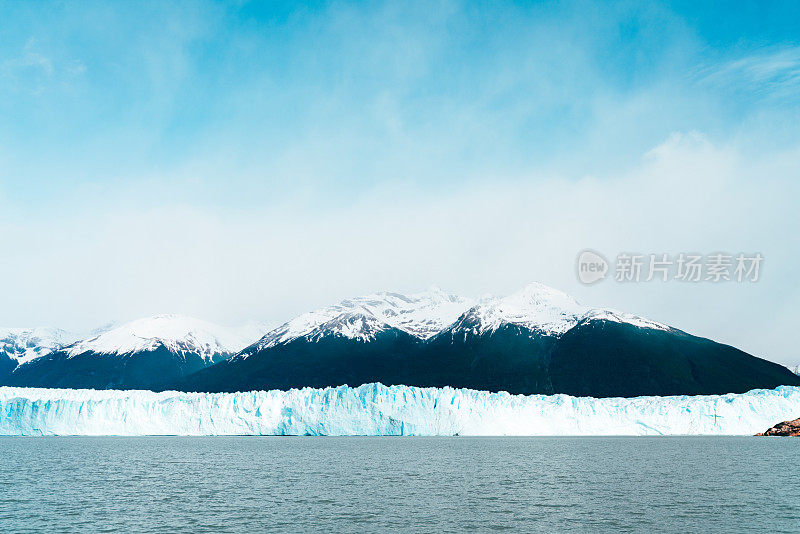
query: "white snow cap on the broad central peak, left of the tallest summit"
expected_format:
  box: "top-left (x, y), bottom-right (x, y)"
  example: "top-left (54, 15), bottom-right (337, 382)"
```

top-left (252, 287), bottom-right (472, 350)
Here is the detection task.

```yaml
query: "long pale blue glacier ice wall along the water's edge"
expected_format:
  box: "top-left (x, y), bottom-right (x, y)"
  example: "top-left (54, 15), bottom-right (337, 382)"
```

top-left (0, 384), bottom-right (800, 436)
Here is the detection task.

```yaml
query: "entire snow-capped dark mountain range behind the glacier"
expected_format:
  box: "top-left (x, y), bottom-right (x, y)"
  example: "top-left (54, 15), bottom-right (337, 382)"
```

top-left (0, 283), bottom-right (800, 397)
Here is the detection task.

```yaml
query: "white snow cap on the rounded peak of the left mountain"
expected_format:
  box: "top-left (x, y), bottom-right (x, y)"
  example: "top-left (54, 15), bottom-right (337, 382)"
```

top-left (65, 315), bottom-right (264, 361)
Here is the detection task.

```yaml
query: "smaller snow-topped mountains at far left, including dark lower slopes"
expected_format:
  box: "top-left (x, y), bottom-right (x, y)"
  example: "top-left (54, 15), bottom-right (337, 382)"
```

top-left (0, 315), bottom-right (265, 389)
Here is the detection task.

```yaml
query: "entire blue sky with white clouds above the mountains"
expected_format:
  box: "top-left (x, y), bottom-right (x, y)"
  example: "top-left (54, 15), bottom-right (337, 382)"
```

top-left (0, 1), bottom-right (800, 364)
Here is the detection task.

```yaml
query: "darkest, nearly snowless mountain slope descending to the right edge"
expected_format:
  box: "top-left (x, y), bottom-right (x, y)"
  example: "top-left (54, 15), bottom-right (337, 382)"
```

top-left (551, 321), bottom-right (800, 397)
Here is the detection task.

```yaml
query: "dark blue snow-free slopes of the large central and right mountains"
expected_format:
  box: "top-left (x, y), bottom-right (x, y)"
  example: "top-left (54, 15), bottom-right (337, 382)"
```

top-left (177, 320), bottom-right (800, 397)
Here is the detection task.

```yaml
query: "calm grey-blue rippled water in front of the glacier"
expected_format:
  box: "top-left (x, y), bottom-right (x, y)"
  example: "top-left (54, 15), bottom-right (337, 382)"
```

top-left (0, 437), bottom-right (800, 532)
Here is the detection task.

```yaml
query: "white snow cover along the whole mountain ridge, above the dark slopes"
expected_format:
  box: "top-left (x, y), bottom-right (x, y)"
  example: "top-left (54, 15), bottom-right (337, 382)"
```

top-left (0, 283), bottom-right (680, 364)
